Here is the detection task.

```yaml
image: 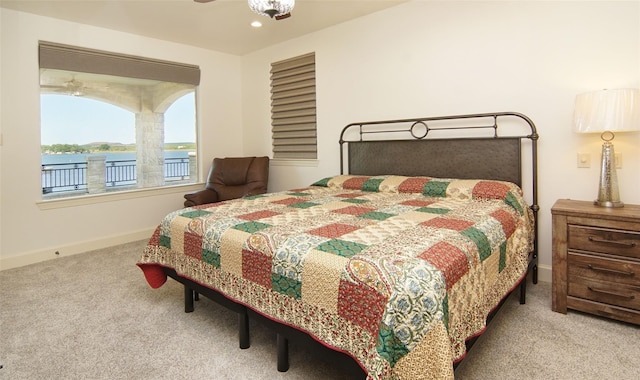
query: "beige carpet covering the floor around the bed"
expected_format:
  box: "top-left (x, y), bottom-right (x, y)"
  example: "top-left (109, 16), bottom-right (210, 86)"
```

top-left (0, 241), bottom-right (640, 379)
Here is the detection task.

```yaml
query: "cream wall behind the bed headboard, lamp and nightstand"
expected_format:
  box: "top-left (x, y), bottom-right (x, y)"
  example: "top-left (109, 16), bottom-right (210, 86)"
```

top-left (242, 1), bottom-right (640, 281)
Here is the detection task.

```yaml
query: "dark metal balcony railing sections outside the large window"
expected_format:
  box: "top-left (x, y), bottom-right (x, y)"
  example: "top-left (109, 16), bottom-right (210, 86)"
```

top-left (42, 158), bottom-right (190, 194)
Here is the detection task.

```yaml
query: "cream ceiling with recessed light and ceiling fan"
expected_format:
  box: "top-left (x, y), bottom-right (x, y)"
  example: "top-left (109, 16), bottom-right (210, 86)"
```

top-left (0, 0), bottom-right (407, 55)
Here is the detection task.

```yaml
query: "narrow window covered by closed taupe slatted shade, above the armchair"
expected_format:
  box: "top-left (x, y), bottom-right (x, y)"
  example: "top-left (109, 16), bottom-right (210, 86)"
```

top-left (271, 53), bottom-right (317, 159)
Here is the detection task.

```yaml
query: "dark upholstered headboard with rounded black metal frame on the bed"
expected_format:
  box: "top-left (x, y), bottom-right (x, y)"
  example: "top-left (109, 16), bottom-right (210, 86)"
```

top-left (340, 112), bottom-right (538, 191)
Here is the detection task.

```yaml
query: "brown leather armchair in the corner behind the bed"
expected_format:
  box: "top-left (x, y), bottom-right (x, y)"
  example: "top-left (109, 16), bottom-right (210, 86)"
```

top-left (184, 156), bottom-right (269, 207)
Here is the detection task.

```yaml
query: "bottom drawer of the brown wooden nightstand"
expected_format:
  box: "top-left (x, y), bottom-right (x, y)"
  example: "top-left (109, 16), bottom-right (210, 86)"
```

top-left (568, 276), bottom-right (640, 310)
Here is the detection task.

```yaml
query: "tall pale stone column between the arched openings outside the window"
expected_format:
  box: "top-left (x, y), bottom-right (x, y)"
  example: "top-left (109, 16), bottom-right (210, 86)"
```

top-left (136, 111), bottom-right (164, 188)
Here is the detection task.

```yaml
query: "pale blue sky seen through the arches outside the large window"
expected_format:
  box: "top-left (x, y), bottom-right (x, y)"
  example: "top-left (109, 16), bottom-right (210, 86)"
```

top-left (40, 93), bottom-right (196, 145)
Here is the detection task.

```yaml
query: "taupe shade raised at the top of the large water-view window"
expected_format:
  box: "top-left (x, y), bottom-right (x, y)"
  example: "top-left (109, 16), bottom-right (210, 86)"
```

top-left (38, 41), bottom-right (200, 86)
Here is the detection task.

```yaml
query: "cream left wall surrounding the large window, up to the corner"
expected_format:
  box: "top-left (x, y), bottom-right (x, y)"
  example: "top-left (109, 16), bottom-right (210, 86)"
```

top-left (0, 8), bottom-right (242, 269)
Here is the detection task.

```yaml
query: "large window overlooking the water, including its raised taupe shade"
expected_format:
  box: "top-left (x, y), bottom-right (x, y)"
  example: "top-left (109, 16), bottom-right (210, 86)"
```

top-left (39, 42), bottom-right (200, 199)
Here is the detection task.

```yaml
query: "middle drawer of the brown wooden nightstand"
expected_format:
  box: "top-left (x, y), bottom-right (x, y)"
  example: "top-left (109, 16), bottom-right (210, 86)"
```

top-left (568, 252), bottom-right (640, 286)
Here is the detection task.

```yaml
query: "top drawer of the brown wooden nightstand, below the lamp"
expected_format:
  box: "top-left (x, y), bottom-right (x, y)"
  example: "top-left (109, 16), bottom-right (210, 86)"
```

top-left (568, 225), bottom-right (640, 259)
